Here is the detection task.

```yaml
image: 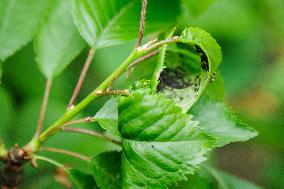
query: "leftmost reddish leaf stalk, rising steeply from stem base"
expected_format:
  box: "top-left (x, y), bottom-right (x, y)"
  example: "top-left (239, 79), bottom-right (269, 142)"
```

top-left (35, 80), bottom-right (52, 138)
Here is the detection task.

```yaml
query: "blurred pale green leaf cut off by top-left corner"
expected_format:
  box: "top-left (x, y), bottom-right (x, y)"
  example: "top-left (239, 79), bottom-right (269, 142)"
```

top-left (0, 0), bottom-right (46, 60)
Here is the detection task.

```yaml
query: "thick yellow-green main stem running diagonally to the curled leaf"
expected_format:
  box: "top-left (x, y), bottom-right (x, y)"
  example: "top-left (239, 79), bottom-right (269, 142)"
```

top-left (27, 37), bottom-right (179, 151)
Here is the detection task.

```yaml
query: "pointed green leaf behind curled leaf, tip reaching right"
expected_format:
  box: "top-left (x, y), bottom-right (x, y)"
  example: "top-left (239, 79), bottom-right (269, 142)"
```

top-left (191, 99), bottom-right (258, 147)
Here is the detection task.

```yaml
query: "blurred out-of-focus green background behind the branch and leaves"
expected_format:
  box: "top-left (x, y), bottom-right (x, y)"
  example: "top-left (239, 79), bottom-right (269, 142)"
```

top-left (0, 0), bottom-right (284, 189)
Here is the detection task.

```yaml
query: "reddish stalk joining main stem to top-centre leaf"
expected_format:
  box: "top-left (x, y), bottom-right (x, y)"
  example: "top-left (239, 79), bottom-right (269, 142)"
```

top-left (68, 48), bottom-right (95, 109)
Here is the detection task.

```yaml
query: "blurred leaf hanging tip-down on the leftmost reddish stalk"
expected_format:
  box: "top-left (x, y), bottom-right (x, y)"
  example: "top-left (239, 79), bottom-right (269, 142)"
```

top-left (34, 0), bottom-right (86, 79)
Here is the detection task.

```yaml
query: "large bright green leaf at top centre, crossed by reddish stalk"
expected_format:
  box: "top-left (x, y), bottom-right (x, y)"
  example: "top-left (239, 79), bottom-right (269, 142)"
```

top-left (73, 0), bottom-right (180, 49)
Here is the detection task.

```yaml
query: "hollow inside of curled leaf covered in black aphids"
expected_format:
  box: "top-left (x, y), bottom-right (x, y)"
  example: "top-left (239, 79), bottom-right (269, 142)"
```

top-left (157, 43), bottom-right (208, 111)
